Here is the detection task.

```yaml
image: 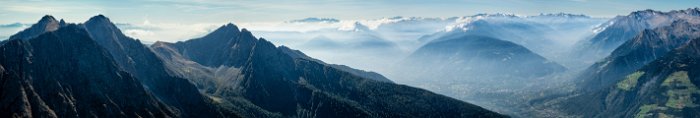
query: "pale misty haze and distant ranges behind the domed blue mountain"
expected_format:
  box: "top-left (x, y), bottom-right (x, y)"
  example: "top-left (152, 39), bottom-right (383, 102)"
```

top-left (253, 13), bottom-right (607, 75)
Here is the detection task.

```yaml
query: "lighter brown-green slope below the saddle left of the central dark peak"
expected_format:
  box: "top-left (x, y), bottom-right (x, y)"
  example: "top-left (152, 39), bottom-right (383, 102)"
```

top-left (151, 39), bottom-right (280, 117)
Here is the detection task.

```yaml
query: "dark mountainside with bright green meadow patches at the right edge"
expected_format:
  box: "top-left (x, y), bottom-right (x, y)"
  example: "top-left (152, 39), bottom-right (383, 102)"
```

top-left (547, 8), bottom-right (700, 117)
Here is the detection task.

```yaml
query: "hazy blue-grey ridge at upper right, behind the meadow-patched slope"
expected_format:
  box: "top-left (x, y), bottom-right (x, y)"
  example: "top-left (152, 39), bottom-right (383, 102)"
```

top-left (572, 8), bottom-right (700, 60)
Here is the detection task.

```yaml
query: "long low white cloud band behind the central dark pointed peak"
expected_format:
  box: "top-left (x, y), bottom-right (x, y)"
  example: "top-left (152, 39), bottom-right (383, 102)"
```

top-left (117, 17), bottom-right (454, 42)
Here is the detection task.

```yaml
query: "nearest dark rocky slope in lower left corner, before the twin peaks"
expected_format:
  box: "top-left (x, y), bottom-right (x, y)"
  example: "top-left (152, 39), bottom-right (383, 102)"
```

top-left (0, 25), bottom-right (176, 117)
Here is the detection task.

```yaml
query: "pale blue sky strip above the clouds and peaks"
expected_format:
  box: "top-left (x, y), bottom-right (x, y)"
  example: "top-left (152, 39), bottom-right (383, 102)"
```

top-left (0, 0), bottom-right (700, 24)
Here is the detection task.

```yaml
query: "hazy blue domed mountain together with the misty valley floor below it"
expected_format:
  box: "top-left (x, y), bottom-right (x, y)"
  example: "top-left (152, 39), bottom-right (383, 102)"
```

top-left (391, 34), bottom-right (566, 117)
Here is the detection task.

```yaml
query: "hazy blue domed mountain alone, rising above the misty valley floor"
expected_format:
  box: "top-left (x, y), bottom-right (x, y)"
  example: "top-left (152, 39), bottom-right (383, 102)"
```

top-left (401, 35), bottom-right (565, 78)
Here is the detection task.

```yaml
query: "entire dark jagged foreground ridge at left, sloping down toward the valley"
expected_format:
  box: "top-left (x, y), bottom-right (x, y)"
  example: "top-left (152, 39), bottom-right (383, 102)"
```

top-left (0, 15), bottom-right (506, 117)
